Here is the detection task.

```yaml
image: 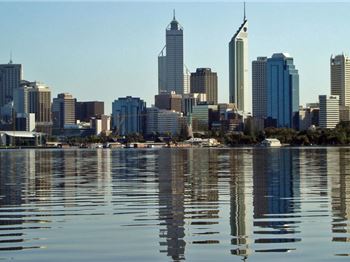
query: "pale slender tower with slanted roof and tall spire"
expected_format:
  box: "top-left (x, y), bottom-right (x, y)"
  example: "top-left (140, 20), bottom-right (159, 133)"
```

top-left (229, 4), bottom-right (249, 111)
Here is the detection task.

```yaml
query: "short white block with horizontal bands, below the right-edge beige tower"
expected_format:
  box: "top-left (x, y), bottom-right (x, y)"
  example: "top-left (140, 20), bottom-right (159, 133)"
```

top-left (319, 95), bottom-right (339, 128)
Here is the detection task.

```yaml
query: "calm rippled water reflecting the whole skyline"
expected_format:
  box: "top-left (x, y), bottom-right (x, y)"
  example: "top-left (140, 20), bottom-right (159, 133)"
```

top-left (0, 148), bottom-right (350, 261)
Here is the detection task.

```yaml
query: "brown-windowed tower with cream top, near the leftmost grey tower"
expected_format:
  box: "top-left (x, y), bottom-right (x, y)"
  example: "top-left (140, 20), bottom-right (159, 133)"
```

top-left (27, 82), bottom-right (52, 134)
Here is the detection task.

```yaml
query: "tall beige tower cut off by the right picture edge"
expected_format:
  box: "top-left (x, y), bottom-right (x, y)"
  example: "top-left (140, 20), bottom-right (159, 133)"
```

top-left (330, 54), bottom-right (350, 106)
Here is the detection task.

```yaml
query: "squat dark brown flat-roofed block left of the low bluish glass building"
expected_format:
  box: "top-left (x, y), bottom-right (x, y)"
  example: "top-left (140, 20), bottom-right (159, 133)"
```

top-left (75, 101), bottom-right (104, 122)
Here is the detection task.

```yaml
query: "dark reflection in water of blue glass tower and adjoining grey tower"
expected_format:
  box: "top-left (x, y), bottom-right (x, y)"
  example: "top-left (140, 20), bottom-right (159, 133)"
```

top-left (253, 148), bottom-right (301, 252)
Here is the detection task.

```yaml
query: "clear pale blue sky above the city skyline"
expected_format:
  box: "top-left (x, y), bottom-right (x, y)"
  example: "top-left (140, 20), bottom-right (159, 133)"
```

top-left (0, 1), bottom-right (350, 113)
